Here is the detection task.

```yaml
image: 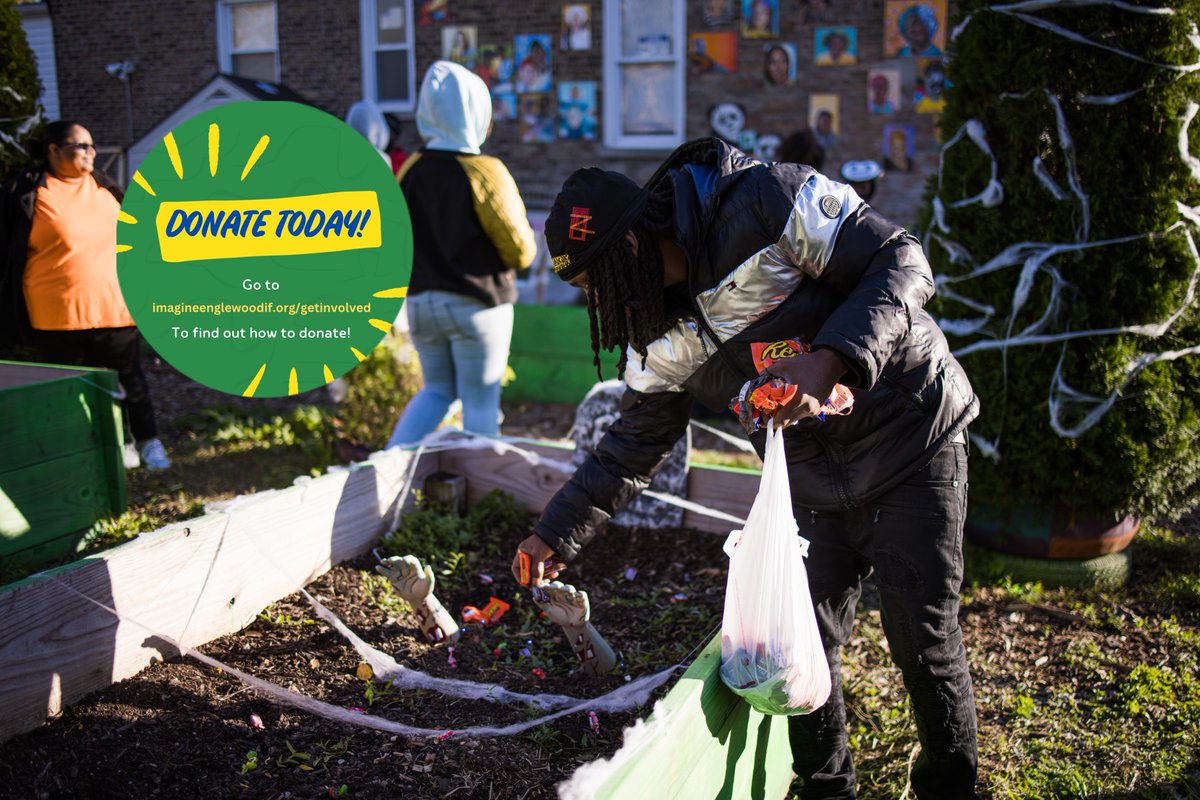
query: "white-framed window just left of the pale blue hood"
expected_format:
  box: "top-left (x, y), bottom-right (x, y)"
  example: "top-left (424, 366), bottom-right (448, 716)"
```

top-left (360, 0), bottom-right (416, 112)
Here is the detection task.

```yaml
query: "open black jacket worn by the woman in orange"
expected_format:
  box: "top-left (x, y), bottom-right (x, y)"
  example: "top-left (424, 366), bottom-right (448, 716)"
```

top-left (0, 168), bottom-right (125, 344)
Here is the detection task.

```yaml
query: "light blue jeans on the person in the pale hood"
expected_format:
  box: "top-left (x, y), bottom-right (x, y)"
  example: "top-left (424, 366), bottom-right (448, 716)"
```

top-left (388, 291), bottom-right (512, 447)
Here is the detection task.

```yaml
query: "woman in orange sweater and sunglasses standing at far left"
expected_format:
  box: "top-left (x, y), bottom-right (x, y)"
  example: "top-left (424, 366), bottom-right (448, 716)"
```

top-left (2, 121), bottom-right (170, 469)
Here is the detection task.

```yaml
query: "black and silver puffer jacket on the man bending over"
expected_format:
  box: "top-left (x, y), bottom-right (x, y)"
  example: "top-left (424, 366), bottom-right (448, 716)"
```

top-left (535, 139), bottom-right (979, 560)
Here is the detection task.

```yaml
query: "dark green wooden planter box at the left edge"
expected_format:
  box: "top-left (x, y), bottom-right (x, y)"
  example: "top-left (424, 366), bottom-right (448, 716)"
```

top-left (0, 361), bottom-right (126, 563)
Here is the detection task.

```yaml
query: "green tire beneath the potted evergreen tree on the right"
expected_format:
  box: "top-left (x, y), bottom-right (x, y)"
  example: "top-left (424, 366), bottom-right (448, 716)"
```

top-left (962, 541), bottom-right (1133, 590)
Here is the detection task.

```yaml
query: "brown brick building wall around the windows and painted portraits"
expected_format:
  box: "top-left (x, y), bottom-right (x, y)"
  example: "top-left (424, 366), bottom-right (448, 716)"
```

top-left (49, 0), bottom-right (937, 223)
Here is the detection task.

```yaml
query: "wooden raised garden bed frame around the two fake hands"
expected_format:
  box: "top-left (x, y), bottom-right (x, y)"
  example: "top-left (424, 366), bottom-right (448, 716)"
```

top-left (0, 445), bottom-right (792, 800)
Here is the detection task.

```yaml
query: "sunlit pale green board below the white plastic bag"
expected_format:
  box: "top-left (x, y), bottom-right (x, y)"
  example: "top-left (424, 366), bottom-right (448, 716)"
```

top-left (595, 634), bottom-right (793, 800)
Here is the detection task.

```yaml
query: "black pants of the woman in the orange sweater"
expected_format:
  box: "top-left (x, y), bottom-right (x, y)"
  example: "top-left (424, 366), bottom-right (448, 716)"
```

top-left (34, 325), bottom-right (158, 443)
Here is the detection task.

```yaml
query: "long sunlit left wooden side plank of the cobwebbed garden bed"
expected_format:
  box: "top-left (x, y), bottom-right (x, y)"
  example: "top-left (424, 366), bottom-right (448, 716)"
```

top-left (0, 451), bottom-right (439, 741)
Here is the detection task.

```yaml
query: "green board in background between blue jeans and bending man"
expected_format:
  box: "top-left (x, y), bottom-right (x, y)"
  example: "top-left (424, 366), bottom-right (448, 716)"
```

top-left (504, 303), bottom-right (600, 403)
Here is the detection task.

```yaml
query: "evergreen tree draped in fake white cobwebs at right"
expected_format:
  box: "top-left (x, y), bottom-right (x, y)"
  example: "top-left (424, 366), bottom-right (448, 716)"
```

top-left (920, 0), bottom-right (1200, 521)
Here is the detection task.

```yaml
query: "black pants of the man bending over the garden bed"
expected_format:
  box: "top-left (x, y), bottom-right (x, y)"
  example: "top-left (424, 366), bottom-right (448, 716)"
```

top-left (788, 444), bottom-right (978, 800)
